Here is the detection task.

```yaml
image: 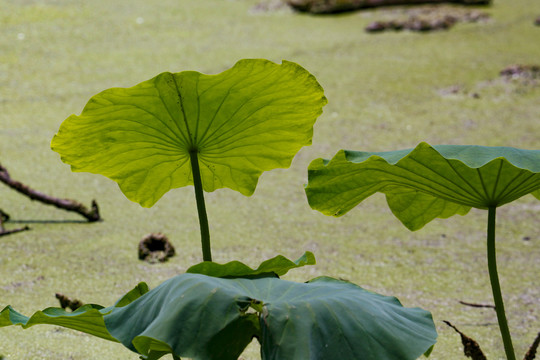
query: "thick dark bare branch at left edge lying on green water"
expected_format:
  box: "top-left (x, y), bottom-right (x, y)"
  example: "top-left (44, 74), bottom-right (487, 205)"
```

top-left (0, 164), bottom-right (101, 222)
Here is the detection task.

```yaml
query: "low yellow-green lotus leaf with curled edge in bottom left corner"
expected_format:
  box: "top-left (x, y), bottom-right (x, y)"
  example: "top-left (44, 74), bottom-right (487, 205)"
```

top-left (0, 283), bottom-right (148, 342)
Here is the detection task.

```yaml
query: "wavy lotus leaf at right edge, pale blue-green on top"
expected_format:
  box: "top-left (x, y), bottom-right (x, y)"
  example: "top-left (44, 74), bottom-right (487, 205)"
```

top-left (306, 143), bottom-right (540, 230)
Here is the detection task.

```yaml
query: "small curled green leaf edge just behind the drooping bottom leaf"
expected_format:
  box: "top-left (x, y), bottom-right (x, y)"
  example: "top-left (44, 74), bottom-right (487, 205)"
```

top-left (186, 251), bottom-right (315, 278)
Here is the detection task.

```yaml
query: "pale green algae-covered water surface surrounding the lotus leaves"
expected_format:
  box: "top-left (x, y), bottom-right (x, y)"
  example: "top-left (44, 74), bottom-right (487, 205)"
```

top-left (0, 0), bottom-right (540, 360)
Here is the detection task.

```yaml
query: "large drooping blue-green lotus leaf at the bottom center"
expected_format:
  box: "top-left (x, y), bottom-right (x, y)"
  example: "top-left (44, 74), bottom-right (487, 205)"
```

top-left (105, 274), bottom-right (437, 360)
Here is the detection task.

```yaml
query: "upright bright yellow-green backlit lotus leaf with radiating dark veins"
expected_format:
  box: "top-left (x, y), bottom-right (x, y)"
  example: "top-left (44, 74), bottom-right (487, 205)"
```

top-left (51, 60), bottom-right (326, 207)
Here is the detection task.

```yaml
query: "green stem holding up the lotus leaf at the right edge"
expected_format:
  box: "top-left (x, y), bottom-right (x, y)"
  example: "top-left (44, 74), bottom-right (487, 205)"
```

top-left (487, 206), bottom-right (516, 360)
